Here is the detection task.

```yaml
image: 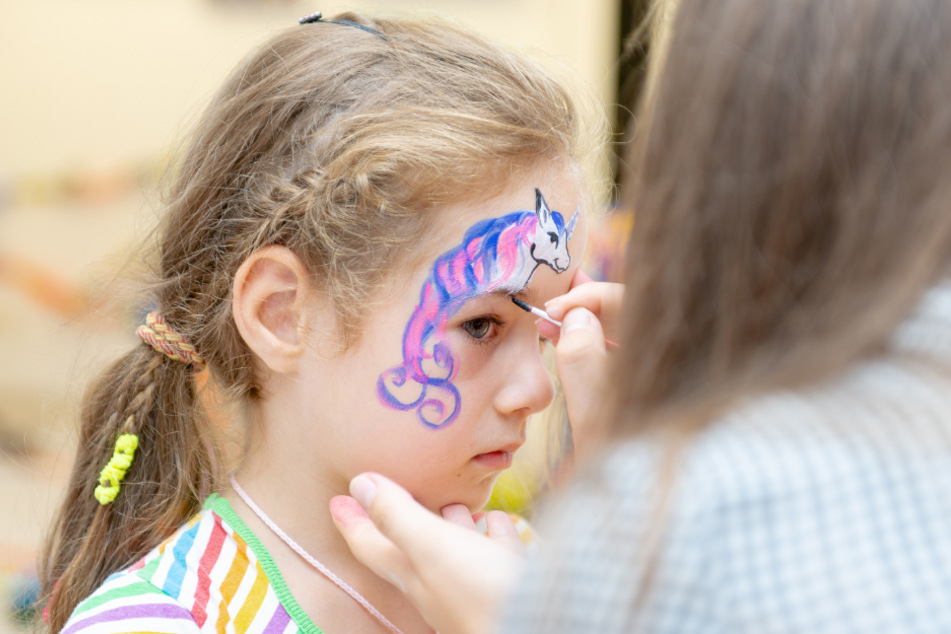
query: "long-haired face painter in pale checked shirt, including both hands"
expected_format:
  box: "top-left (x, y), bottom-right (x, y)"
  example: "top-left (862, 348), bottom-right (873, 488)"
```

top-left (335, 0), bottom-right (951, 634)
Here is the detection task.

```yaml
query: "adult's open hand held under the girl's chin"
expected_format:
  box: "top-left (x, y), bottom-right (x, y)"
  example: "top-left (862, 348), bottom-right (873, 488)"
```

top-left (330, 473), bottom-right (524, 634)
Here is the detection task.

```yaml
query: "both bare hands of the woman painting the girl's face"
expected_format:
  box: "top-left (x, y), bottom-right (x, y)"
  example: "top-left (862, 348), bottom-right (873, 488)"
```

top-left (330, 276), bottom-right (623, 634)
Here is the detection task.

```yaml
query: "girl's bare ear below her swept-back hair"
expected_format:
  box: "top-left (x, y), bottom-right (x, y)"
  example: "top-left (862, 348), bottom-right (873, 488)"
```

top-left (231, 245), bottom-right (320, 374)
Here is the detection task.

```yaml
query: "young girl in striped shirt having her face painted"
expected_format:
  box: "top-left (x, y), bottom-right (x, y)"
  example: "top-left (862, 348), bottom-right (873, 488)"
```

top-left (42, 14), bottom-right (591, 633)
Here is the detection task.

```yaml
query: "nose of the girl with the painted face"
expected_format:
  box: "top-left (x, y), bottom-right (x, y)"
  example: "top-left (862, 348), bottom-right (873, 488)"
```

top-left (495, 334), bottom-right (555, 418)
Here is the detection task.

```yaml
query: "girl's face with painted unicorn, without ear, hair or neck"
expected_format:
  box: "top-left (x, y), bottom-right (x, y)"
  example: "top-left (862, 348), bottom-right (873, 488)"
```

top-left (301, 165), bottom-right (587, 510)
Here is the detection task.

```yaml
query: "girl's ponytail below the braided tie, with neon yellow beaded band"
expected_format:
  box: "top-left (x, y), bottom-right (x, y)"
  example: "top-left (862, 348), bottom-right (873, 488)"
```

top-left (41, 328), bottom-right (217, 631)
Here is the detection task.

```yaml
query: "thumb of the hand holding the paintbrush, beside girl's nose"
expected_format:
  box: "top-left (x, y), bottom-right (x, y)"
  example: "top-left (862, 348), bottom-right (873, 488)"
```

top-left (555, 307), bottom-right (608, 449)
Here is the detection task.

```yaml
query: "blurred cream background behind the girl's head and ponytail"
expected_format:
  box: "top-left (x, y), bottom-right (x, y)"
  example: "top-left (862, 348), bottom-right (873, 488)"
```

top-left (0, 0), bottom-right (638, 634)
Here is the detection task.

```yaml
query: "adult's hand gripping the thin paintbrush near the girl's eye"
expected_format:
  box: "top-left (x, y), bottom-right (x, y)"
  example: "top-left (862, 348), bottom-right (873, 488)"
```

top-left (538, 270), bottom-right (624, 458)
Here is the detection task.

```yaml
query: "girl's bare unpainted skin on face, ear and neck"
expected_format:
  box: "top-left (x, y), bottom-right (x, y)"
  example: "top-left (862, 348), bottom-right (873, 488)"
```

top-left (224, 163), bottom-right (587, 632)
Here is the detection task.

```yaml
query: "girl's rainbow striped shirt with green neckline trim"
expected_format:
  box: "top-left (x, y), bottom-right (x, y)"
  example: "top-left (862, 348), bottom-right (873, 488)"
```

top-left (63, 495), bottom-right (321, 634)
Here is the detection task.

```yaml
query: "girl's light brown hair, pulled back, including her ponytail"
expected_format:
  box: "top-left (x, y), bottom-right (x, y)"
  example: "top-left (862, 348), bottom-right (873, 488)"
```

top-left (41, 14), bottom-right (593, 631)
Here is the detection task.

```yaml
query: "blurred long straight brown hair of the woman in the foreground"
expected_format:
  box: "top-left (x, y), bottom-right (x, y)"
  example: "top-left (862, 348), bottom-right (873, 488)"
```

top-left (614, 0), bottom-right (951, 438)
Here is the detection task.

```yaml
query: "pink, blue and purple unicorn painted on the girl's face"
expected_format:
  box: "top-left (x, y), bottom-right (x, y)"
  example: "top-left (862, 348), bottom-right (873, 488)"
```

top-left (377, 189), bottom-right (578, 429)
